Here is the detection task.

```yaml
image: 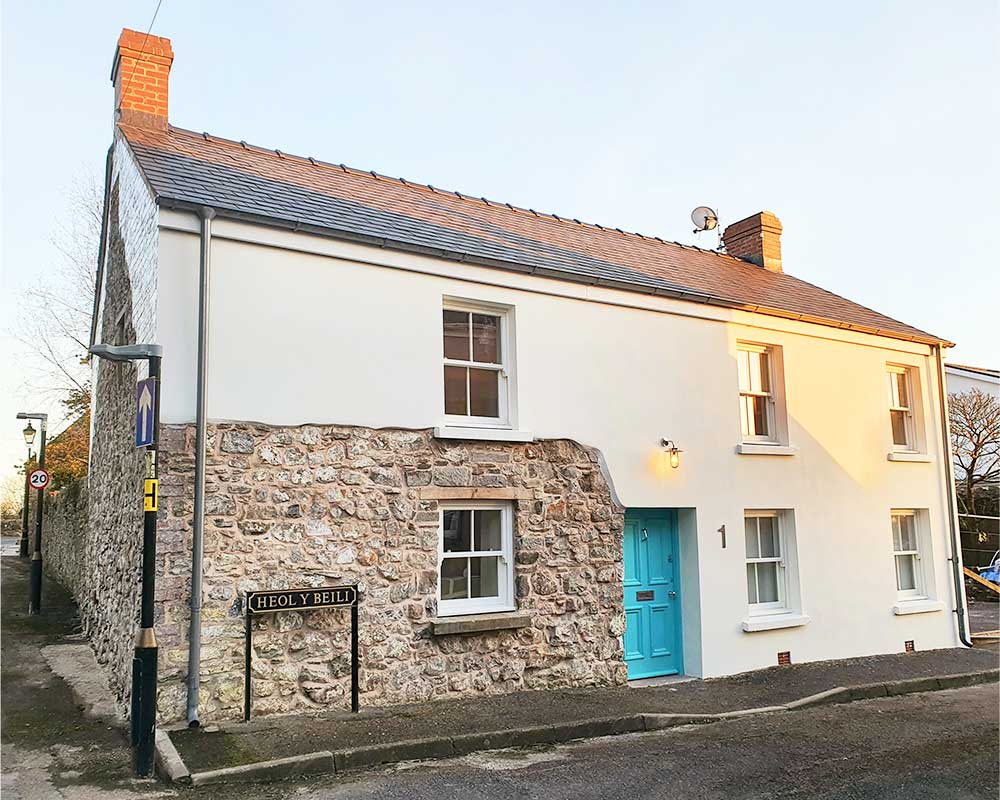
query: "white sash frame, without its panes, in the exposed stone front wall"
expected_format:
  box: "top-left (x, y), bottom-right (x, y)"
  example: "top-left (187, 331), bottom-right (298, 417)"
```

top-left (437, 500), bottom-right (517, 617)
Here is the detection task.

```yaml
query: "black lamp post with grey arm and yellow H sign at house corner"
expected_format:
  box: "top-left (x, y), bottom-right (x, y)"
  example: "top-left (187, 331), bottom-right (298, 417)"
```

top-left (90, 344), bottom-right (163, 777)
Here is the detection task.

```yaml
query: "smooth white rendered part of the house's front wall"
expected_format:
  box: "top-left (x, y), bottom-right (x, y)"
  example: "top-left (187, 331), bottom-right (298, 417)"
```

top-left (160, 215), bottom-right (957, 676)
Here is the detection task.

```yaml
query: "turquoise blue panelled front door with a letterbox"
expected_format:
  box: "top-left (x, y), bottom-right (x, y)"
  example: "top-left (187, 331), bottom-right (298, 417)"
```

top-left (625, 509), bottom-right (683, 680)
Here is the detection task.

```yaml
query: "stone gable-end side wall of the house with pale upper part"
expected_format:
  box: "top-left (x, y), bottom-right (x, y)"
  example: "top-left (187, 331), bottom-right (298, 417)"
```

top-left (63, 136), bottom-right (157, 713)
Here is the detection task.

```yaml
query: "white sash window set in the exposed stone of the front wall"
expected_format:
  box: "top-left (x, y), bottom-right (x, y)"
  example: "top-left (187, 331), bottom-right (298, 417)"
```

top-left (438, 503), bottom-right (514, 616)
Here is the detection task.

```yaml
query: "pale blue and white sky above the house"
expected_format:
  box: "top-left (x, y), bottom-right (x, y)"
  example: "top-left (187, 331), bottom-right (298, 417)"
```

top-left (0, 0), bottom-right (1000, 490)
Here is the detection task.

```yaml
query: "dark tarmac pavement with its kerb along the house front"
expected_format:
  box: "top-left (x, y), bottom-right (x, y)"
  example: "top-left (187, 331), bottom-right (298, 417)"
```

top-left (170, 649), bottom-right (1000, 784)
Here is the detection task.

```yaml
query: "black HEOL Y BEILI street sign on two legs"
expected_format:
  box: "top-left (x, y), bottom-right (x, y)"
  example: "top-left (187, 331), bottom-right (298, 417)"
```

top-left (243, 585), bottom-right (359, 722)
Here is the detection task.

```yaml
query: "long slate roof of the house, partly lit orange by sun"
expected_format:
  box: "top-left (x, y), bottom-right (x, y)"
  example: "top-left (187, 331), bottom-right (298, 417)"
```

top-left (119, 125), bottom-right (950, 345)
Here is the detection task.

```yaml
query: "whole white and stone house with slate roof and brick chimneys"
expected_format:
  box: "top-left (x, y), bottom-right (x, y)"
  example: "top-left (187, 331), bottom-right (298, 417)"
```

top-left (56, 30), bottom-right (964, 721)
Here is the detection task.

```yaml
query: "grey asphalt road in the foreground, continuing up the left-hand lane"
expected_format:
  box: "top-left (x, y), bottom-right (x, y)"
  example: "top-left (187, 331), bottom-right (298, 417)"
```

top-left (0, 558), bottom-right (1000, 800)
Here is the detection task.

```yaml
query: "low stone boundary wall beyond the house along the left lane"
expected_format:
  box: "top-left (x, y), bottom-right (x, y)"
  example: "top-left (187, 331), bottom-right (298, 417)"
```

top-left (42, 478), bottom-right (90, 597)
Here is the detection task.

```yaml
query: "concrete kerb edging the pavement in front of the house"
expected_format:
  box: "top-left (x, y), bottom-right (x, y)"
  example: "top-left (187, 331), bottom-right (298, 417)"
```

top-left (182, 669), bottom-right (1000, 786)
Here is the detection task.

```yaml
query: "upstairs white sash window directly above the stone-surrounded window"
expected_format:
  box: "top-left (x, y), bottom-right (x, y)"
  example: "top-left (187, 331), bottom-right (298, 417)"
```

top-left (442, 303), bottom-right (509, 426)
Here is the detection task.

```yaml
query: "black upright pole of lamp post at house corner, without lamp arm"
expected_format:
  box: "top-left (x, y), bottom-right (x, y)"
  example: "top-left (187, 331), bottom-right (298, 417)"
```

top-left (134, 356), bottom-right (161, 777)
